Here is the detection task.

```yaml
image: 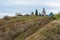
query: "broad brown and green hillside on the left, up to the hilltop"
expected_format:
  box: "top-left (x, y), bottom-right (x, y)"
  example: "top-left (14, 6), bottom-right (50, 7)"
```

top-left (0, 16), bottom-right (40, 40)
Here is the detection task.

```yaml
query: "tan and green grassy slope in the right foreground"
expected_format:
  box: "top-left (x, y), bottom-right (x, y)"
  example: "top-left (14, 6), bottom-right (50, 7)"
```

top-left (26, 20), bottom-right (60, 40)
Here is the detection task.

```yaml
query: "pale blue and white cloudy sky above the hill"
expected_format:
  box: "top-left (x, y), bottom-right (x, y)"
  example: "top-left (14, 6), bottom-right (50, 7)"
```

top-left (0, 0), bottom-right (60, 17)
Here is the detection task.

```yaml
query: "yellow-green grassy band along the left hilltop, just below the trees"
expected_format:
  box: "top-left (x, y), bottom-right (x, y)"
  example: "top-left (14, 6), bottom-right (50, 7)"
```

top-left (0, 16), bottom-right (39, 28)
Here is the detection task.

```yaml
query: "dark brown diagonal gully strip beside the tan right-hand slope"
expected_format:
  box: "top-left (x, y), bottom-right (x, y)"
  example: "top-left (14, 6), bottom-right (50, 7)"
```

top-left (15, 18), bottom-right (50, 40)
